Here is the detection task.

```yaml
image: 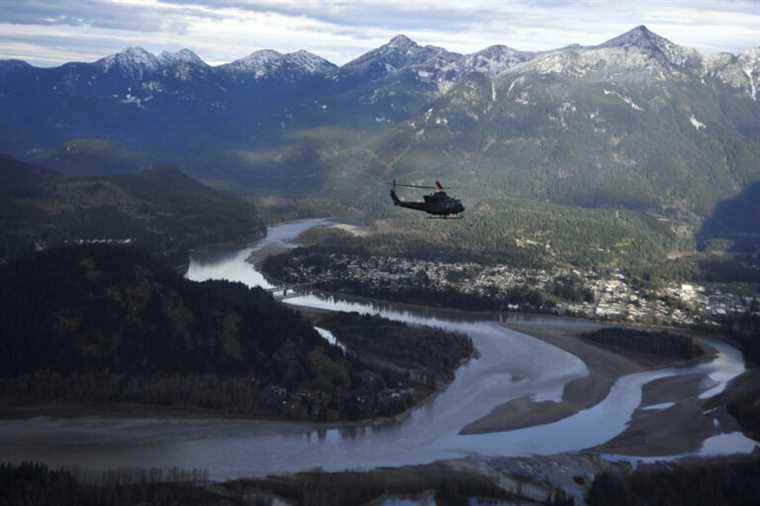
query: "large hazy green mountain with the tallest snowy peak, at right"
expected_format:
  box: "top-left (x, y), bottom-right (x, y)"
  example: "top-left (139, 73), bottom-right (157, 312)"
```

top-left (331, 27), bottom-right (760, 218)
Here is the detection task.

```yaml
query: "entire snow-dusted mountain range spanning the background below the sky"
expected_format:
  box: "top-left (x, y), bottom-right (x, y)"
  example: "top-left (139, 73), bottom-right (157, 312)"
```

top-left (0, 26), bottom-right (760, 219)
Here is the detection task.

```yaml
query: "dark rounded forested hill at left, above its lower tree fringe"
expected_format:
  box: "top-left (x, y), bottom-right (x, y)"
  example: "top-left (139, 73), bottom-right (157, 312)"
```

top-left (0, 245), bottom-right (322, 379)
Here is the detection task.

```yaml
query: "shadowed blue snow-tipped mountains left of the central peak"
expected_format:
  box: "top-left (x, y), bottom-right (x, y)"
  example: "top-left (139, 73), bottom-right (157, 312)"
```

top-left (0, 48), bottom-right (333, 161)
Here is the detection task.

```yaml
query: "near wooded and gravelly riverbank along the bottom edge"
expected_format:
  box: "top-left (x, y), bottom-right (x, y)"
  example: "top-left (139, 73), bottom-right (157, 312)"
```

top-left (0, 454), bottom-right (616, 506)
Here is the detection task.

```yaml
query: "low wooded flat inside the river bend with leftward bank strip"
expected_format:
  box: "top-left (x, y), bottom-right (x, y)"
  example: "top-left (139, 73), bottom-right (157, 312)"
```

top-left (0, 310), bottom-right (477, 431)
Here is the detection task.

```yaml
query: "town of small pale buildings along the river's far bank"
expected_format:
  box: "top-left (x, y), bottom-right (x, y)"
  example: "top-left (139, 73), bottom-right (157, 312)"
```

top-left (287, 253), bottom-right (760, 325)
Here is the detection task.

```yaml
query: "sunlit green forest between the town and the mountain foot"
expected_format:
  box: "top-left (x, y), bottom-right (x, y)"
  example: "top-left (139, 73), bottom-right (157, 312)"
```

top-left (272, 199), bottom-right (693, 279)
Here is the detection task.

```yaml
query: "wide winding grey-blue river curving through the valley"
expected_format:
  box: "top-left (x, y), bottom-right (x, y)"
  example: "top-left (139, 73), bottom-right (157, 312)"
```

top-left (0, 220), bottom-right (754, 479)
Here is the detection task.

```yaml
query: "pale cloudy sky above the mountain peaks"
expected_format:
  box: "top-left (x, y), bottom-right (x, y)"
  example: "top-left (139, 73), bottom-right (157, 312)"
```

top-left (0, 0), bottom-right (760, 66)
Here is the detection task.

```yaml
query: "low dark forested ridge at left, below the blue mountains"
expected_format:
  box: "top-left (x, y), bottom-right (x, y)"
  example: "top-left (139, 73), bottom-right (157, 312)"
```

top-left (0, 155), bottom-right (264, 264)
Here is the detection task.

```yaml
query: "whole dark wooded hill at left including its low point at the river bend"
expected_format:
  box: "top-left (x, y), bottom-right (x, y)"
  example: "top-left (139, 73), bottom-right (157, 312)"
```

top-left (0, 244), bottom-right (472, 420)
